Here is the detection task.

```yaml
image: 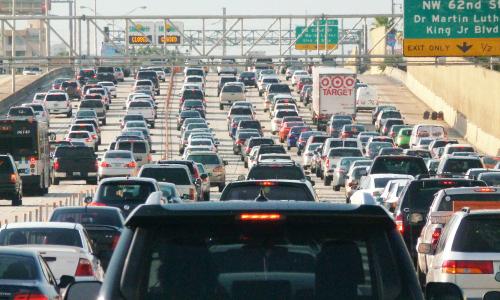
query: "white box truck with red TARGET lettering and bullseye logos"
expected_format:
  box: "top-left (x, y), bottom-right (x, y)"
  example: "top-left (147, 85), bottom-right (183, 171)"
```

top-left (312, 67), bottom-right (356, 130)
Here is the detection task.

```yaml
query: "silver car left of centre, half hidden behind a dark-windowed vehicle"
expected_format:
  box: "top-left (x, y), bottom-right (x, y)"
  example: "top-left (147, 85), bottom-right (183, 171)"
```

top-left (186, 151), bottom-right (227, 192)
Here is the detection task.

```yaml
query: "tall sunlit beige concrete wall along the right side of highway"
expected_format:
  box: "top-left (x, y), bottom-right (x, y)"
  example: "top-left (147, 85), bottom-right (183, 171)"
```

top-left (384, 65), bottom-right (500, 155)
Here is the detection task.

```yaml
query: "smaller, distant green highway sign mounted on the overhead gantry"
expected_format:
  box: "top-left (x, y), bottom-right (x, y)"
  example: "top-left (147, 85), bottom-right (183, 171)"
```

top-left (295, 20), bottom-right (339, 50)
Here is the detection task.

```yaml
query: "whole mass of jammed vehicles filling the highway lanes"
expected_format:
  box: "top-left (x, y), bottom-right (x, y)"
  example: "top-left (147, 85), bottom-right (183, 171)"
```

top-left (0, 58), bottom-right (500, 300)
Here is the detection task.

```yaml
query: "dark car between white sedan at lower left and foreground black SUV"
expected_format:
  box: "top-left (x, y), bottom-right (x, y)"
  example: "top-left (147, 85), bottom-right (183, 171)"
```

top-left (49, 206), bottom-right (125, 270)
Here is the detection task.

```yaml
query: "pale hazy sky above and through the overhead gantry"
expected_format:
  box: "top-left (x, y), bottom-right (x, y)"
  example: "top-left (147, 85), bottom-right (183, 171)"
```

top-left (46, 0), bottom-right (403, 55)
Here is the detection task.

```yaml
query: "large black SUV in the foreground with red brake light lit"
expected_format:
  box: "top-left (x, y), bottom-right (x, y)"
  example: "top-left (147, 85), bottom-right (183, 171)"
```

top-left (66, 201), bottom-right (423, 300)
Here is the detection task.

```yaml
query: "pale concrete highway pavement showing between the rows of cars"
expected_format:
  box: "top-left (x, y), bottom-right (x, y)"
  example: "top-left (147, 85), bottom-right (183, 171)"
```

top-left (0, 72), bottom-right (459, 223)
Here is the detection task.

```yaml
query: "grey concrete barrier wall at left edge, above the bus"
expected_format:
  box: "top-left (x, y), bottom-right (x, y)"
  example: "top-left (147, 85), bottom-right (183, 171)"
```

top-left (0, 68), bottom-right (73, 114)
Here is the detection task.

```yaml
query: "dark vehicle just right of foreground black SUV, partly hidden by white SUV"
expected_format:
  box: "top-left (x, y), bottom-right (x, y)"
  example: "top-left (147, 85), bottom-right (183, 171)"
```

top-left (394, 178), bottom-right (486, 263)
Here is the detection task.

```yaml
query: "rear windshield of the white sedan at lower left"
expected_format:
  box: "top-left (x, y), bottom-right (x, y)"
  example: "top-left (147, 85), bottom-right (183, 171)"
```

top-left (0, 228), bottom-right (82, 247)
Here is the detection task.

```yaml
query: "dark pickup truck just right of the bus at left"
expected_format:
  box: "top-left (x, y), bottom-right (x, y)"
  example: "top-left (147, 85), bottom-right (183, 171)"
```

top-left (51, 146), bottom-right (98, 185)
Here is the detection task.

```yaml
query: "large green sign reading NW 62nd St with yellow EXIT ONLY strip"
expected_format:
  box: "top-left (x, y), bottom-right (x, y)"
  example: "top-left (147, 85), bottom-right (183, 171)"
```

top-left (403, 0), bottom-right (500, 56)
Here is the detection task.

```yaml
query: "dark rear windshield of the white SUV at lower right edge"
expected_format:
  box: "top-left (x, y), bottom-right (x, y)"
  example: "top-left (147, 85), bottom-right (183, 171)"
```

top-left (451, 216), bottom-right (500, 253)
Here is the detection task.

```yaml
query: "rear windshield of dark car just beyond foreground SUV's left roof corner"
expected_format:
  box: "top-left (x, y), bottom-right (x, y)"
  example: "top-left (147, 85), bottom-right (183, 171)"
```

top-left (96, 181), bottom-right (156, 204)
